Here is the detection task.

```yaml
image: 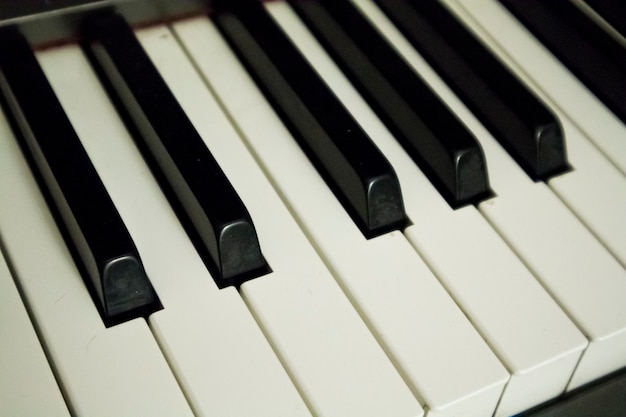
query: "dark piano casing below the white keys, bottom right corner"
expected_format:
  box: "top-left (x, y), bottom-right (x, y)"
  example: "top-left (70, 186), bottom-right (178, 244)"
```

top-left (516, 369), bottom-right (626, 417)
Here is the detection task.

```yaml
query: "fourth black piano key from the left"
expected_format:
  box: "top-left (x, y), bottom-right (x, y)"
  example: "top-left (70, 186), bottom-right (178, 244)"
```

top-left (290, 0), bottom-right (490, 207)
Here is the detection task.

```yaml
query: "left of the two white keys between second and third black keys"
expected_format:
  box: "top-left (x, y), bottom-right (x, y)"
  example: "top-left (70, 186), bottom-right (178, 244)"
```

top-left (138, 22), bottom-right (422, 417)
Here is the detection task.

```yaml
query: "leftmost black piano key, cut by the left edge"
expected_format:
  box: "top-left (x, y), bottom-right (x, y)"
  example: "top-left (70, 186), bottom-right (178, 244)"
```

top-left (0, 28), bottom-right (160, 325)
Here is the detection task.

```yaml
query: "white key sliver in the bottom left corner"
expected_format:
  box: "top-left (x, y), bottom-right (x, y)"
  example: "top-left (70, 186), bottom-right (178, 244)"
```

top-left (0, 247), bottom-right (70, 417)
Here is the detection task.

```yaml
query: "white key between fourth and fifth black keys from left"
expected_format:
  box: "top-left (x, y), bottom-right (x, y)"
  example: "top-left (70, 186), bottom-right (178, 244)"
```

top-left (358, 0), bottom-right (626, 389)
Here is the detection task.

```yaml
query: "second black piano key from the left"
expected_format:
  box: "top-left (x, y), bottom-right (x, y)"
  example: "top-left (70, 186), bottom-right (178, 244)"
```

top-left (84, 13), bottom-right (268, 288)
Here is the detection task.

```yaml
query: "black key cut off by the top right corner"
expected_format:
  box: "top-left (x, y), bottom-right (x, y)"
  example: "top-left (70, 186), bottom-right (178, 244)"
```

top-left (500, 0), bottom-right (626, 122)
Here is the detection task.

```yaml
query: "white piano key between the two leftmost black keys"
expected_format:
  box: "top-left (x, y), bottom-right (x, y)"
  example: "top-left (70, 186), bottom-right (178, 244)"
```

top-left (38, 43), bottom-right (310, 417)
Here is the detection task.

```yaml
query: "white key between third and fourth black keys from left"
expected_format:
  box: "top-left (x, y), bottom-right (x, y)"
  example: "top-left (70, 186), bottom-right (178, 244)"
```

top-left (266, 1), bottom-right (586, 415)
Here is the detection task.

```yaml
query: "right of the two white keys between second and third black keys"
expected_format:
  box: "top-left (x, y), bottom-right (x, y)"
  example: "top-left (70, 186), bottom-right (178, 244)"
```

top-left (174, 8), bottom-right (508, 417)
